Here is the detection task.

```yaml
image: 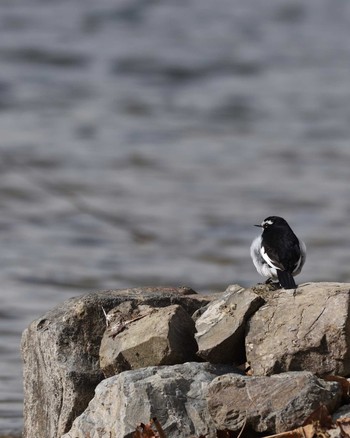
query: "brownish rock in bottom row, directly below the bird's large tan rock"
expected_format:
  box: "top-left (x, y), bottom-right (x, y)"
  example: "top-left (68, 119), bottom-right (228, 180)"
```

top-left (208, 371), bottom-right (341, 433)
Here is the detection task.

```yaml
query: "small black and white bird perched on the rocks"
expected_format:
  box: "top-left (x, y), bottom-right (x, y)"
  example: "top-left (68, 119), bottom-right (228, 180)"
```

top-left (250, 216), bottom-right (306, 289)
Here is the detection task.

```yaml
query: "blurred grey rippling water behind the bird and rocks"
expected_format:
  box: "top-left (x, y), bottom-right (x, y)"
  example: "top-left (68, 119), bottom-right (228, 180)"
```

top-left (0, 0), bottom-right (350, 432)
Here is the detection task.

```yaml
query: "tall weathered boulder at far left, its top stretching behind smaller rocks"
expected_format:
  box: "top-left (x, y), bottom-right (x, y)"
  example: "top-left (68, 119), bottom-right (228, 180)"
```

top-left (22, 287), bottom-right (210, 438)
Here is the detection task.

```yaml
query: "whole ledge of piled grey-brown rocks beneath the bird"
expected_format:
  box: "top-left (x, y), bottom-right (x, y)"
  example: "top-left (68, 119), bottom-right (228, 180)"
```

top-left (22, 283), bottom-right (350, 438)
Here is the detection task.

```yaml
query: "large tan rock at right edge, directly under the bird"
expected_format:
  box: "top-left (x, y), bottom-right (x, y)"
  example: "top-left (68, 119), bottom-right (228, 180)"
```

top-left (246, 283), bottom-right (350, 376)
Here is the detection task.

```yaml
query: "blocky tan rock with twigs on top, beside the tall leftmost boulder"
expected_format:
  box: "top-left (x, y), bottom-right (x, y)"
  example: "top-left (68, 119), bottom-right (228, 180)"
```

top-left (100, 304), bottom-right (197, 377)
